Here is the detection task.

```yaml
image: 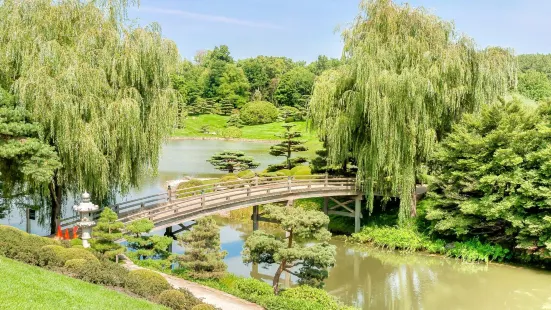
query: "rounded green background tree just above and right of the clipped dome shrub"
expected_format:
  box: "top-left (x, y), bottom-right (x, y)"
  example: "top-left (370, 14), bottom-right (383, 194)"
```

top-left (274, 67), bottom-right (315, 107)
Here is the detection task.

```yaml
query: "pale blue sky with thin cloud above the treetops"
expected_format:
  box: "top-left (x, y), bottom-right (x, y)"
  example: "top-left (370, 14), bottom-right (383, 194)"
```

top-left (129, 0), bottom-right (551, 62)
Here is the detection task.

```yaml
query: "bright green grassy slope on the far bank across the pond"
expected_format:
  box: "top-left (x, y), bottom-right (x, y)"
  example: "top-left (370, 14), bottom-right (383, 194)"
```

top-left (172, 114), bottom-right (322, 157)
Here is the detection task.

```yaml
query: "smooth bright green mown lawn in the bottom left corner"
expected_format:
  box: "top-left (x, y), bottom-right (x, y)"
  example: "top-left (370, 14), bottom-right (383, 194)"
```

top-left (0, 256), bottom-right (167, 310)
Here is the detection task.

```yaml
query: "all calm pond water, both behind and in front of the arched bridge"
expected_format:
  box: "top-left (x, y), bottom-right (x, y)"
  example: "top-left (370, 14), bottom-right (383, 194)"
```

top-left (4, 140), bottom-right (551, 310)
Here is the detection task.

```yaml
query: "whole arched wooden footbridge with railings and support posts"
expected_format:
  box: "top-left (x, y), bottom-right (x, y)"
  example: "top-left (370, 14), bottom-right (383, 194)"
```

top-left (61, 175), bottom-right (362, 231)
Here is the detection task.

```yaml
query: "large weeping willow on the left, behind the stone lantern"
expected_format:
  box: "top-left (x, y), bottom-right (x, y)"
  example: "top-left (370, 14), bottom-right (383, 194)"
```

top-left (0, 0), bottom-right (179, 232)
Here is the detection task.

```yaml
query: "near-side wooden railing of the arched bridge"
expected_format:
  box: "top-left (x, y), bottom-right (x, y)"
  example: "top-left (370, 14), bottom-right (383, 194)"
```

top-left (121, 176), bottom-right (355, 222)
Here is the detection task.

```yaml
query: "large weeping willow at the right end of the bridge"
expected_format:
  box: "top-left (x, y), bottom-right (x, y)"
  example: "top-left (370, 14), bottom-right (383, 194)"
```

top-left (310, 0), bottom-right (516, 220)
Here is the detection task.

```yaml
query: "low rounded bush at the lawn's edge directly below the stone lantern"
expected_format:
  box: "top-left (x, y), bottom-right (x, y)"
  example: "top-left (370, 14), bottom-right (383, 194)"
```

top-left (72, 260), bottom-right (129, 287)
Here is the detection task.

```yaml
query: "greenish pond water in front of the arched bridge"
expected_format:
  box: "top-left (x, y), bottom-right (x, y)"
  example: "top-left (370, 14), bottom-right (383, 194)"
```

top-left (162, 218), bottom-right (551, 310)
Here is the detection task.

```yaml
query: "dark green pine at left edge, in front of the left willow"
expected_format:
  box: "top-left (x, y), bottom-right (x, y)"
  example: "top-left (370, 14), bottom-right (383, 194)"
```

top-left (0, 87), bottom-right (61, 218)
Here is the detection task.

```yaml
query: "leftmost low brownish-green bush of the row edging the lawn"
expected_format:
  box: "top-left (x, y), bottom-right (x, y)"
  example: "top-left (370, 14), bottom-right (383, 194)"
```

top-left (0, 225), bottom-right (60, 265)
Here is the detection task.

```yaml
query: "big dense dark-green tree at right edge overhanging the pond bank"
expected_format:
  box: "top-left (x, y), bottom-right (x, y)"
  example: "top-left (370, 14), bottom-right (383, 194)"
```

top-left (426, 101), bottom-right (551, 259)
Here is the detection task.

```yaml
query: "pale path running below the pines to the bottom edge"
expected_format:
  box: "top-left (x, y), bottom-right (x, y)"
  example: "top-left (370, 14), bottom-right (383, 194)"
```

top-left (124, 257), bottom-right (264, 310)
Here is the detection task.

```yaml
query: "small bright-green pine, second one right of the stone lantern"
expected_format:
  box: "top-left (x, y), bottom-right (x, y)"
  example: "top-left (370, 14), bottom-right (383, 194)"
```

top-left (126, 219), bottom-right (172, 258)
